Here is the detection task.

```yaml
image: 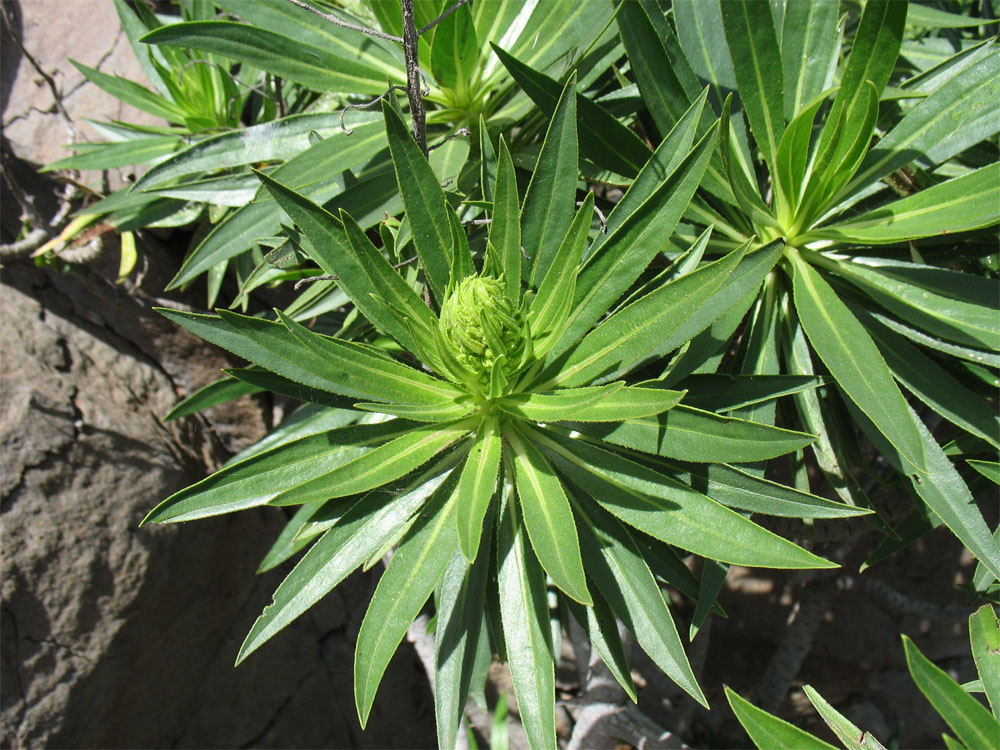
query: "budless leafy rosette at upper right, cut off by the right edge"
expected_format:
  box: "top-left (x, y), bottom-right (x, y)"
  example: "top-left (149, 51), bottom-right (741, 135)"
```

top-left (600, 0), bottom-right (1000, 591)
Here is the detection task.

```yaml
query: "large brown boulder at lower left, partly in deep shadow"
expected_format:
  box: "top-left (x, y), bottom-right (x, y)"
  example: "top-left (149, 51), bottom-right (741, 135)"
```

top-left (0, 264), bottom-right (435, 748)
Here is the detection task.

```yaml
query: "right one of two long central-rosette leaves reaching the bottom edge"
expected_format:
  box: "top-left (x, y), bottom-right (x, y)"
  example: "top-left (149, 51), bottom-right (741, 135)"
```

top-left (497, 465), bottom-right (560, 750)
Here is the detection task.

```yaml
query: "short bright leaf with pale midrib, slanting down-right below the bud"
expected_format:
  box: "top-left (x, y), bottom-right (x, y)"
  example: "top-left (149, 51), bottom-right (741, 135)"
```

top-left (504, 430), bottom-right (592, 605)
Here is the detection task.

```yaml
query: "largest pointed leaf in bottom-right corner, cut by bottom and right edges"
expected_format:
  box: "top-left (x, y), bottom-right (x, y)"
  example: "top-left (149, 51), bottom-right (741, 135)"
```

top-left (903, 635), bottom-right (1000, 748)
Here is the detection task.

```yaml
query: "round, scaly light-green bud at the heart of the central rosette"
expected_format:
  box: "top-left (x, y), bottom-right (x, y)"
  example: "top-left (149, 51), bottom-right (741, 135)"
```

top-left (440, 276), bottom-right (528, 394)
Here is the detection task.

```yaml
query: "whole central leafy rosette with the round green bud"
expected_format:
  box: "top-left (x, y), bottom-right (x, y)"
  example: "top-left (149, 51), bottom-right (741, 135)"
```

top-left (147, 82), bottom-right (864, 748)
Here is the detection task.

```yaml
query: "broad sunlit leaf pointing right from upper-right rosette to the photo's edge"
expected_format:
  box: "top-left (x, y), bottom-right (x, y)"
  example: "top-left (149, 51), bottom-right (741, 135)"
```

top-left (798, 163), bottom-right (1000, 245)
